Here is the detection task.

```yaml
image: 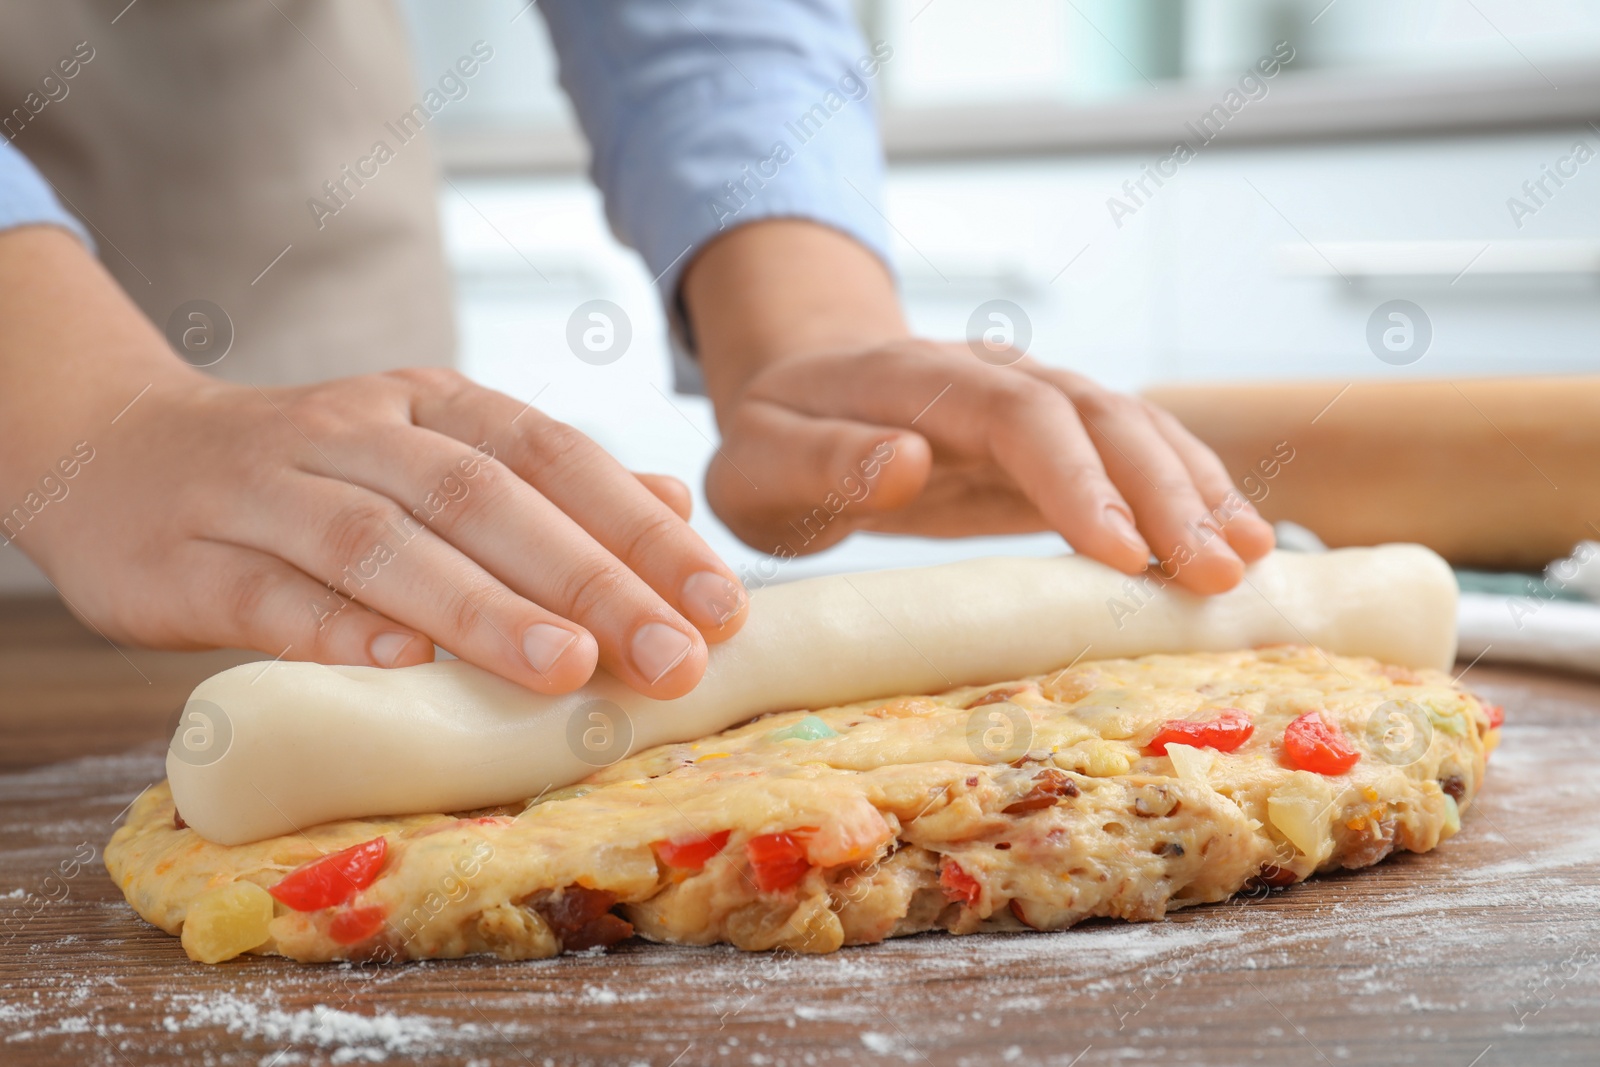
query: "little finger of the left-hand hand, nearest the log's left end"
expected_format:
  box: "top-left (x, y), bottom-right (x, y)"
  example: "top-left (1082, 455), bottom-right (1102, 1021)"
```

top-left (167, 541), bottom-right (434, 667)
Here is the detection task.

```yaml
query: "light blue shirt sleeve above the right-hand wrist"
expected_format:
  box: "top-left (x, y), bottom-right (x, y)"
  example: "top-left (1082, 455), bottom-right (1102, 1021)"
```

top-left (539, 0), bottom-right (893, 358)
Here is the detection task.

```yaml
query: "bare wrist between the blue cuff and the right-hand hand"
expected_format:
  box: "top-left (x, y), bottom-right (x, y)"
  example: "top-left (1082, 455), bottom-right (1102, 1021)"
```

top-left (682, 219), bottom-right (909, 414)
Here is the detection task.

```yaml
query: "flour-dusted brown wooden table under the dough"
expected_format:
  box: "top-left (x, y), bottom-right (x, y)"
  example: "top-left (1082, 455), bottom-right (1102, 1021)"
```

top-left (0, 603), bottom-right (1600, 1067)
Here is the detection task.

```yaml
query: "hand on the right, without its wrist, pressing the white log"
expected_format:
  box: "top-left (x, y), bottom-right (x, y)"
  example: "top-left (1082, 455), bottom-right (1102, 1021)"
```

top-left (706, 341), bottom-right (1274, 593)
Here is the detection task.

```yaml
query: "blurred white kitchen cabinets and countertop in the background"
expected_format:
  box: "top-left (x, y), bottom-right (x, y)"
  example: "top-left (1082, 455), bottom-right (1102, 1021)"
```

top-left (406, 0), bottom-right (1600, 577)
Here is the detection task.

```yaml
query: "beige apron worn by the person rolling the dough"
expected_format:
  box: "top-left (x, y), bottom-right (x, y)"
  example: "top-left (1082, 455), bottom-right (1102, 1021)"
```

top-left (0, 0), bottom-right (454, 592)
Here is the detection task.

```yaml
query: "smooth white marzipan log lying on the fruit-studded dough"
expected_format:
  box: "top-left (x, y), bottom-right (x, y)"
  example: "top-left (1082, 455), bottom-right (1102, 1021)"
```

top-left (166, 545), bottom-right (1456, 845)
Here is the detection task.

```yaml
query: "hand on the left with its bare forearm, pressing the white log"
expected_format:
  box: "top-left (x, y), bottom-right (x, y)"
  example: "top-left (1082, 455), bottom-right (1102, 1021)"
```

top-left (0, 230), bottom-right (746, 699)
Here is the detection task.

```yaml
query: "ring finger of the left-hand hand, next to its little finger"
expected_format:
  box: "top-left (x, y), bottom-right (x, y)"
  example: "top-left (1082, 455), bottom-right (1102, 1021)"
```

top-left (229, 474), bottom-right (598, 693)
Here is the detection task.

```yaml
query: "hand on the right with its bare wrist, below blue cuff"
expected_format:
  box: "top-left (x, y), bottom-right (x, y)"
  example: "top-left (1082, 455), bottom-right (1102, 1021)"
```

top-left (683, 219), bottom-right (1272, 593)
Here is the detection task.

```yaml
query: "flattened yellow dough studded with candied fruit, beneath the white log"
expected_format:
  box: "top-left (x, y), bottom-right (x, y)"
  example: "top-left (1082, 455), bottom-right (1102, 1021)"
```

top-left (106, 645), bottom-right (1499, 963)
